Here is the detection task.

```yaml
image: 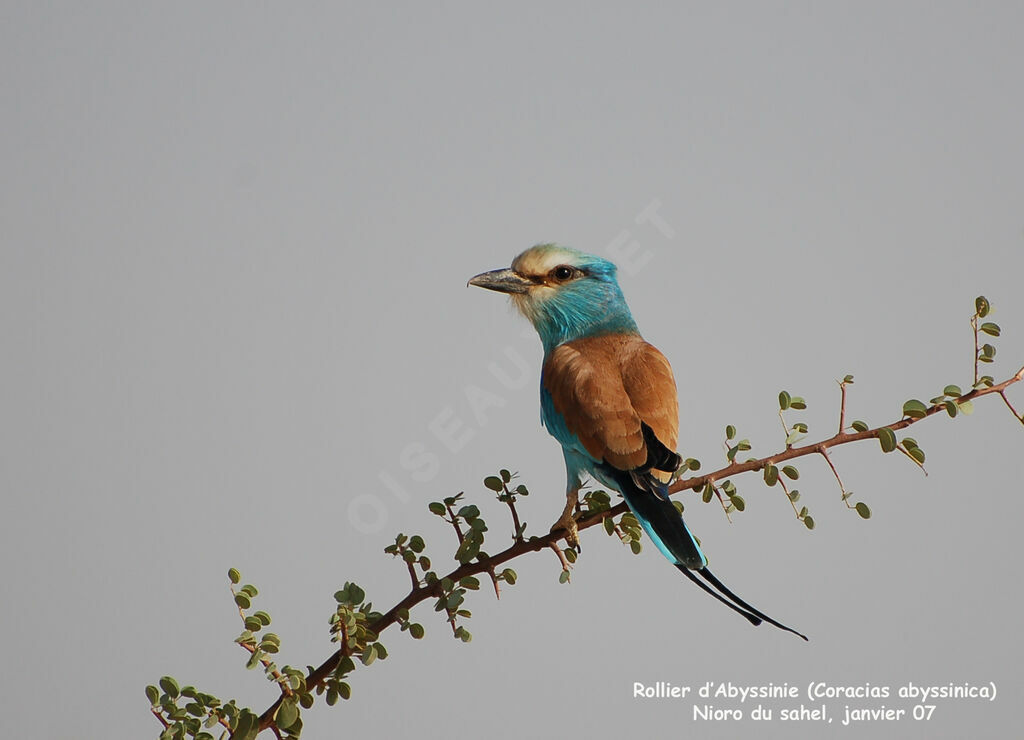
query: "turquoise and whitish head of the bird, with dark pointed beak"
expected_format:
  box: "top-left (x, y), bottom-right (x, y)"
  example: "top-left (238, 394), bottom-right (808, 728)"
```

top-left (469, 244), bottom-right (637, 349)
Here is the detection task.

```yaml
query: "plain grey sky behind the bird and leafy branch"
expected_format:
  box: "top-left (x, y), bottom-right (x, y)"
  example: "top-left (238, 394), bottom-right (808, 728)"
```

top-left (0, 2), bottom-right (1024, 738)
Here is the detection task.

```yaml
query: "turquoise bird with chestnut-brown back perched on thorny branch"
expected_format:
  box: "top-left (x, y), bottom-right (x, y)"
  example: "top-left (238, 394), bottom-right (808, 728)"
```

top-left (468, 244), bottom-right (807, 640)
